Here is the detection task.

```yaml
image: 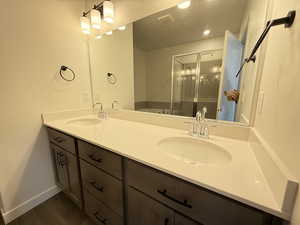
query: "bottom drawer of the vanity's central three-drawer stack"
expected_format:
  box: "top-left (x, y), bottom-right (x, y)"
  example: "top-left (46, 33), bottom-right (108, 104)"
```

top-left (84, 191), bottom-right (123, 225)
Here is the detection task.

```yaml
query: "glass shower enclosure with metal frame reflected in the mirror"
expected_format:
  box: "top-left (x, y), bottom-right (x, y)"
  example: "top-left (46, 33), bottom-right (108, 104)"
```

top-left (170, 50), bottom-right (222, 119)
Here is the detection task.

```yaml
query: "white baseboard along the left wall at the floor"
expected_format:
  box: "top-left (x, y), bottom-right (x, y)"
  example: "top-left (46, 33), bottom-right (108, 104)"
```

top-left (2, 186), bottom-right (61, 224)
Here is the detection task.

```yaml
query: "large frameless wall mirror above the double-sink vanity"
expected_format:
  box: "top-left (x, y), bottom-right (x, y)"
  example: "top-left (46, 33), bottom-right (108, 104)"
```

top-left (90, 0), bottom-right (267, 124)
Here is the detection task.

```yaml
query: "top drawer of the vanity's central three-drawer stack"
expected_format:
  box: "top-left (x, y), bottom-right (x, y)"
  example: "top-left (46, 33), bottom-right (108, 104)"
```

top-left (77, 140), bottom-right (122, 179)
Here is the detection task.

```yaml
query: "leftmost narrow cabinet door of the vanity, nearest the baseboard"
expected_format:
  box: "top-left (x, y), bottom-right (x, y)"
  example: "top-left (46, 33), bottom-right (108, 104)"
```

top-left (50, 145), bottom-right (69, 192)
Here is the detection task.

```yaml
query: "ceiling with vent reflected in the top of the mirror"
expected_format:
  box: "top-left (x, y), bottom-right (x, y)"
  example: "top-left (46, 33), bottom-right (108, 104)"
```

top-left (133, 0), bottom-right (247, 51)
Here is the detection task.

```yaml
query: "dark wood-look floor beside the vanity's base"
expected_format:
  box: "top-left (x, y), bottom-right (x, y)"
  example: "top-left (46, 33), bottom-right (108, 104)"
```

top-left (9, 193), bottom-right (94, 225)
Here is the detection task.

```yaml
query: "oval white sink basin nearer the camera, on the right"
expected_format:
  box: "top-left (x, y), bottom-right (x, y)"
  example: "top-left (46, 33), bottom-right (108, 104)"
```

top-left (157, 137), bottom-right (232, 166)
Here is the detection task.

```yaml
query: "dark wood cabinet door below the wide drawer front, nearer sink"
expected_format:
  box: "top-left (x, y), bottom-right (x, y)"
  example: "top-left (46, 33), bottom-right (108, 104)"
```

top-left (128, 187), bottom-right (174, 225)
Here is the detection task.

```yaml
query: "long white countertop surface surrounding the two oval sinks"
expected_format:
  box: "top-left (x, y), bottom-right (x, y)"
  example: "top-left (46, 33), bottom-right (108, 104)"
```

top-left (44, 114), bottom-right (287, 219)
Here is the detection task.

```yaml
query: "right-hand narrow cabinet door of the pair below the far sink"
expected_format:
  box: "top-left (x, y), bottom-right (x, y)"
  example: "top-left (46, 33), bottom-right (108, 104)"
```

top-left (65, 152), bottom-right (82, 207)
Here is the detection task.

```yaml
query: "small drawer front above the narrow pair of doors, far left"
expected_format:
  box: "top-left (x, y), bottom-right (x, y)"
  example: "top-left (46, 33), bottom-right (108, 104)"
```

top-left (48, 128), bottom-right (76, 154)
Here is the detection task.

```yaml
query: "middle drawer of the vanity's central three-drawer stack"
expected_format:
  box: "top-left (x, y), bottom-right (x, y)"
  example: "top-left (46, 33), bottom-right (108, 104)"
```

top-left (80, 160), bottom-right (123, 216)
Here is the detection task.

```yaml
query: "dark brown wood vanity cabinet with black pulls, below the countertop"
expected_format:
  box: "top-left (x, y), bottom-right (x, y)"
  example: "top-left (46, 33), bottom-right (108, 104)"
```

top-left (48, 128), bottom-right (282, 225)
